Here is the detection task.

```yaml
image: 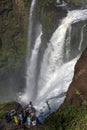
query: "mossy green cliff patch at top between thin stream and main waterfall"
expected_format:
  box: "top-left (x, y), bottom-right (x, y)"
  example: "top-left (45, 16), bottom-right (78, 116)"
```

top-left (36, 0), bottom-right (57, 40)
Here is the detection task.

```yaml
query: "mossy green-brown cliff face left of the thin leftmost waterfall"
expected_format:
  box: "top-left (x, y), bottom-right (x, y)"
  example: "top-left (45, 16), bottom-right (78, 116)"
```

top-left (0, 0), bottom-right (30, 74)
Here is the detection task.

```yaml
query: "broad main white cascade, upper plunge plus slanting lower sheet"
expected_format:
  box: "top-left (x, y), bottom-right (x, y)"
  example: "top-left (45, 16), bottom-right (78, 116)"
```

top-left (35, 10), bottom-right (87, 119)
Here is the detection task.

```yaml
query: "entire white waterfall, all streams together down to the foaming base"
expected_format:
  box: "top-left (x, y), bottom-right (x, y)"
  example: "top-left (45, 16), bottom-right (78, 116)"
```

top-left (20, 0), bottom-right (87, 121)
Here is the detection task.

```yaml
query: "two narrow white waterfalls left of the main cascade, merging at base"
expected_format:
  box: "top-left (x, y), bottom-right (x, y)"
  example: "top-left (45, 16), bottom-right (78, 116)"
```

top-left (19, 0), bottom-right (42, 103)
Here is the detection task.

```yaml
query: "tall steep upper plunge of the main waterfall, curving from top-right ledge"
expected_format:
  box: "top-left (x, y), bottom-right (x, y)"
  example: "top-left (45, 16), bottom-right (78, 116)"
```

top-left (38, 10), bottom-right (87, 95)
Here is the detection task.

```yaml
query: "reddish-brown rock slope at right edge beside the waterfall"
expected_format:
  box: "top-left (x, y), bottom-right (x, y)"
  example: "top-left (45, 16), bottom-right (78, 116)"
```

top-left (64, 48), bottom-right (87, 106)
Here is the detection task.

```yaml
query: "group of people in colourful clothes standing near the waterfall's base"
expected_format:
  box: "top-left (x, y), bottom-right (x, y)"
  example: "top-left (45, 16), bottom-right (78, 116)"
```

top-left (6, 101), bottom-right (37, 127)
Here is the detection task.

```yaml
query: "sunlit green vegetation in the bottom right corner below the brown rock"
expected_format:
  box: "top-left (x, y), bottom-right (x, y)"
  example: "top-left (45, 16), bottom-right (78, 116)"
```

top-left (45, 106), bottom-right (87, 130)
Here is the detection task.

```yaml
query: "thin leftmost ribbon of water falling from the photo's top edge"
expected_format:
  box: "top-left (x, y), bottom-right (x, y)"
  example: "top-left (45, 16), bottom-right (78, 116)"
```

top-left (24, 0), bottom-right (36, 98)
